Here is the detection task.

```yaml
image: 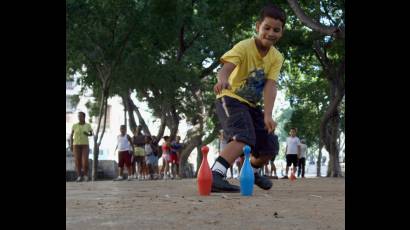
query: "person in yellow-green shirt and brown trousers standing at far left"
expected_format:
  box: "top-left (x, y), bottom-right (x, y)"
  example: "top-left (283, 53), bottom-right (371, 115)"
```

top-left (70, 112), bottom-right (93, 182)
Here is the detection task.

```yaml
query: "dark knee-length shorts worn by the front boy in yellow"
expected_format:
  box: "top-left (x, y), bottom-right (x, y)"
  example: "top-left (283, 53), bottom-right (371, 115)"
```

top-left (215, 96), bottom-right (275, 157)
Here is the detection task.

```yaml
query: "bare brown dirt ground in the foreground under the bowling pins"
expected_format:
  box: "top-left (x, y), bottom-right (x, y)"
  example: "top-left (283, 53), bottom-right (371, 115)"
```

top-left (66, 178), bottom-right (345, 230)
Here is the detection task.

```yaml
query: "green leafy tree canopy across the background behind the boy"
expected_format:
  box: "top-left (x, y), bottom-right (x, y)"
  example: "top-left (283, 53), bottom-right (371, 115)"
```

top-left (66, 0), bottom-right (344, 160)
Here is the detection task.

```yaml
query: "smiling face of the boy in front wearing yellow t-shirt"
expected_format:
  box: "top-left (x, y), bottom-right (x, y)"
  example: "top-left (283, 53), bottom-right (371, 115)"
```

top-left (256, 17), bottom-right (283, 48)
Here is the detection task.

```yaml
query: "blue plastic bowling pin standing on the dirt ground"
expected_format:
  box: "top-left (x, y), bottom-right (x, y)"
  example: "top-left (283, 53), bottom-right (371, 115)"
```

top-left (239, 145), bottom-right (255, 196)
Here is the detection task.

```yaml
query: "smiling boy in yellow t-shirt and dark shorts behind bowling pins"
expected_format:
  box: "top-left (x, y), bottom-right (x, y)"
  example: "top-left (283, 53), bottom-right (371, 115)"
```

top-left (212, 4), bottom-right (286, 192)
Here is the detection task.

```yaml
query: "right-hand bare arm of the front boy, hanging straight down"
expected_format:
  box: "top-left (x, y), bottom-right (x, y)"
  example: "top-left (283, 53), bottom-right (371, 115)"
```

top-left (263, 79), bottom-right (277, 133)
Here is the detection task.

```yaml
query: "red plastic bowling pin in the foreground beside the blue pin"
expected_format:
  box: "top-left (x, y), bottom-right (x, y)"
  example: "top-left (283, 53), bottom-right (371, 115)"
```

top-left (197, 146), bottom-right (212, 196)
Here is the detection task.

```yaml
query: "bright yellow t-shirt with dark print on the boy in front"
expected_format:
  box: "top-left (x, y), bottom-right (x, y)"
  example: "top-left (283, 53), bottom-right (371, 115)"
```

top-left (217, 38), bottom-right (283, 107)
